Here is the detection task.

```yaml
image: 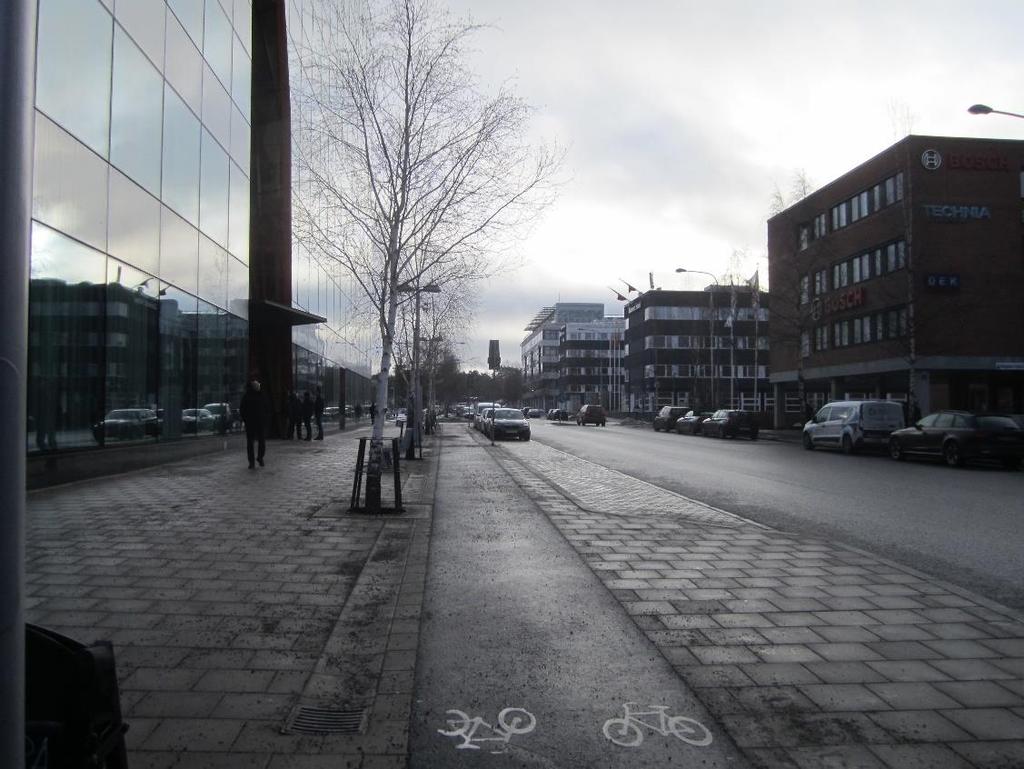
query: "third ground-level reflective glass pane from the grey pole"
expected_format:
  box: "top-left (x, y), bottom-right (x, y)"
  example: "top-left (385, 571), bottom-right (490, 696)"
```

top-left (159, 284), bottom-right (199, 438)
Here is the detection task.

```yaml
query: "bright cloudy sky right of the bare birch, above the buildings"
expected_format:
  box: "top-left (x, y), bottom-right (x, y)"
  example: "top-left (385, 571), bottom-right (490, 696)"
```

top-left (439, 0), bottom-right (1024, 369)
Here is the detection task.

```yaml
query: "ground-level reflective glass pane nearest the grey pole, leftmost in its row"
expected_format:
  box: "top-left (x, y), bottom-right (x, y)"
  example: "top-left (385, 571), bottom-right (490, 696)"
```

top-left (27, 222), bottom-right (105, 452)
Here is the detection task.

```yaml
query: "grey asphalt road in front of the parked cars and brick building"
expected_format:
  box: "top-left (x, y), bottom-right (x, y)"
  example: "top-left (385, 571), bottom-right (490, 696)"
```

top-left (531, 420), bottom-right (1024, 609)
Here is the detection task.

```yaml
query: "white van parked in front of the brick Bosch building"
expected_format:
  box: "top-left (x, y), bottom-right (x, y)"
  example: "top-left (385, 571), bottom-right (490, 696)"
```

top-left (803, 400), bottom-right (904, 454)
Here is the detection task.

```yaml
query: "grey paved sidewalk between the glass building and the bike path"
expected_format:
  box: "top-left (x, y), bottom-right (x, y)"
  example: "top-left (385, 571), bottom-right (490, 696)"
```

top-left (26, 430), bottom-right (433, 769)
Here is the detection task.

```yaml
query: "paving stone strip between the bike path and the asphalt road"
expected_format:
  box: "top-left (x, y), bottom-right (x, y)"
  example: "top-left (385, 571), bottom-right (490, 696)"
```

top-left (483, 434), bottom-right (1024, 769)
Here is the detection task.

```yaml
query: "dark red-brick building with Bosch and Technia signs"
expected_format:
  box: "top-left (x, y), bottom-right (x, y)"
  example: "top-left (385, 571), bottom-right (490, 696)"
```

top-left (768, 135), bottom-right (1024, 425)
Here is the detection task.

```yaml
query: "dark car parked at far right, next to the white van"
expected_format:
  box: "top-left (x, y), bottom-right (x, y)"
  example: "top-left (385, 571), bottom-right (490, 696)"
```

top-left (889, 411), bottom-right (1024, 470)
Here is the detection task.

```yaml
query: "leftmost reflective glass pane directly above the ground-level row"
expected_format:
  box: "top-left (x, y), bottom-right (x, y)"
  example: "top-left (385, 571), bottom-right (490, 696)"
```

top-left (32, 113), bottom-right (109, 249)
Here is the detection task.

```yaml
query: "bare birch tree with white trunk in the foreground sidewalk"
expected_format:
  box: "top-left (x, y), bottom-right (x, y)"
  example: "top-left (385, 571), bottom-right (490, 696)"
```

top-left (295, 0), bottom-right (558, 507)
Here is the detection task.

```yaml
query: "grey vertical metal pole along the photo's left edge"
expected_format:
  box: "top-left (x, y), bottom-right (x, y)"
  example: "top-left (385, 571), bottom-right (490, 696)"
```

top-left (0, 0), bottom-right (36, 767)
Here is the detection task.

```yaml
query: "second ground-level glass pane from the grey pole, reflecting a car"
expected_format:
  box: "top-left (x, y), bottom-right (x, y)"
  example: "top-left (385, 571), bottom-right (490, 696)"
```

top-left (103, 259), bottom-right (161, 444)
